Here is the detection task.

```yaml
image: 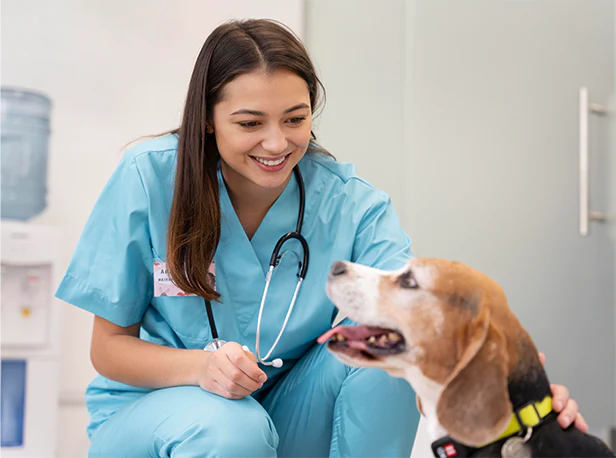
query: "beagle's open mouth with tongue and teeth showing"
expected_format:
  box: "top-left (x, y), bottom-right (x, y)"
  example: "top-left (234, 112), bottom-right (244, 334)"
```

top-left (317, 326), bottom-right (405, 359)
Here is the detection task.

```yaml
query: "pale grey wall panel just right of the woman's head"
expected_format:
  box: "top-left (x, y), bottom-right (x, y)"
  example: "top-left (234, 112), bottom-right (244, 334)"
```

top-left (306, 0), bottom-right (405, 213)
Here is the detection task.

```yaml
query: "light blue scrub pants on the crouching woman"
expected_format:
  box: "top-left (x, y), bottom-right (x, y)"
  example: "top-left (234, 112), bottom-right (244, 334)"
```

top-left (89, 338), bottom-right (419, 458)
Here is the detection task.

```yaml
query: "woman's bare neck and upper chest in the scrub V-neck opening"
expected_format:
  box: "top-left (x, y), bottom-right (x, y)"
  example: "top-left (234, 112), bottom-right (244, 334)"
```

top-left (222, 167), bottom-right (291, 239)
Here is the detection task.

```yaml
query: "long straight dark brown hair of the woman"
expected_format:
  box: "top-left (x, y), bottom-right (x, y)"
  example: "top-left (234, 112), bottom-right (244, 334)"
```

top-left (166, 19), bottom-right (327, 300)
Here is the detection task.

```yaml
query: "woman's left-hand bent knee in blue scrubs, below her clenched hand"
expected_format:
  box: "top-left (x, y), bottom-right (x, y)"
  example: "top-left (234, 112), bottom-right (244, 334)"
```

top-left (90, 387), bottom-right (278, 458)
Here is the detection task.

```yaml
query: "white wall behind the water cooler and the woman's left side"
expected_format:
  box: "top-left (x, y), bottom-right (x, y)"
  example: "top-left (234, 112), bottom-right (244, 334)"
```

top-left (0, 0), bottom-right (304, 458)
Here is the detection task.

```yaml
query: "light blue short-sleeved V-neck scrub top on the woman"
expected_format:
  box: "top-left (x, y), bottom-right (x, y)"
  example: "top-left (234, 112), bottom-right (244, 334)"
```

top-left (56, 135), bottom-right (411, 432)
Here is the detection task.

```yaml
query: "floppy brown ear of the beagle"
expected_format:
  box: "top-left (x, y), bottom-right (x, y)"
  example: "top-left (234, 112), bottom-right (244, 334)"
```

top-left (436, 304), bottom-right (512, 447)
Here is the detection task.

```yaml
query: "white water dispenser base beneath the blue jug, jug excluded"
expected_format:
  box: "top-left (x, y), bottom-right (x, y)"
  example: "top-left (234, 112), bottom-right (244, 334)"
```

top-left (0, 221), bottom-right (60, 458)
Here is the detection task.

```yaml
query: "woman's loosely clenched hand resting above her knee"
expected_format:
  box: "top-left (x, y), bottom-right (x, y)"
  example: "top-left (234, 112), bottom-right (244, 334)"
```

top-left (198, 342), bottom-right (267, 399)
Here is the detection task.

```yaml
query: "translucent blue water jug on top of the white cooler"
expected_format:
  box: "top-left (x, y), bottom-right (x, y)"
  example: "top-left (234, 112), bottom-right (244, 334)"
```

top-left (0, 87), bottom-right (51, 221)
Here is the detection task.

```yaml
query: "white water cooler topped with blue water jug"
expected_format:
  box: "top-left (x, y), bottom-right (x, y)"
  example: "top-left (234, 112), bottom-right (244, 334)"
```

top-left (0, 87), bottom-right (60, 458)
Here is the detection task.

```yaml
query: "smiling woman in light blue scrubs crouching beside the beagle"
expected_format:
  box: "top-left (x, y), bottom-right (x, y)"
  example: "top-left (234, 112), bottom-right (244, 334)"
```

top-left (57, 20), bottom-right (581, 458)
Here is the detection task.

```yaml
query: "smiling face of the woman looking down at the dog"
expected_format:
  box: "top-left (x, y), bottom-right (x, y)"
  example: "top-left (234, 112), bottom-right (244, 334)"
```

top-left (212, 69), bottom-right (312, 194)
